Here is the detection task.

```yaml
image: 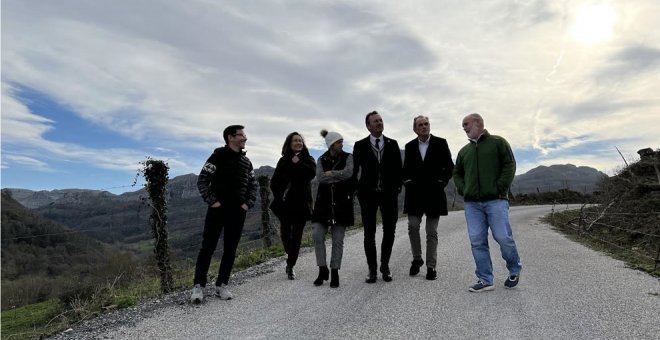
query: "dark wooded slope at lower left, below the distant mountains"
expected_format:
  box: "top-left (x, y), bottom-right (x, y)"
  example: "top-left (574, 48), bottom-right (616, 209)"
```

top-left (2, 190), bottom-right (135, 310)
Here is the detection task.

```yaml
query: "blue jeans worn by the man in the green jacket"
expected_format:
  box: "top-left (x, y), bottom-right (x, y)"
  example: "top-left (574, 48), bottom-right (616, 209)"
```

top-left (465, 199), bottom-right (522, 284)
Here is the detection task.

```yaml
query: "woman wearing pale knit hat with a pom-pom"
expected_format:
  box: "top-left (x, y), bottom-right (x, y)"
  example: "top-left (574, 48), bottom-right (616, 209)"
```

top-left (312, 130), bottom-right (355, 288)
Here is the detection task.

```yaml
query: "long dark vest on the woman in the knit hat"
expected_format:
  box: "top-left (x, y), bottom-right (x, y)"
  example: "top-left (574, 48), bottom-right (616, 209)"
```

top-left (312, 151), bottom-right (355, 227)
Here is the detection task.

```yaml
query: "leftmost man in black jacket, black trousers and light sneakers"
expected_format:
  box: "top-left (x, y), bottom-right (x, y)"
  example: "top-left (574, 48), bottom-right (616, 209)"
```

top-left (190, 125), bottom-right (257, 303)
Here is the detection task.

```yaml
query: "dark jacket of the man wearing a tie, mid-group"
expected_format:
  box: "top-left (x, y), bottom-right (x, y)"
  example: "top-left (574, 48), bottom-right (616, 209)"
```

top-left (353, 136), bottom-right (402, 195)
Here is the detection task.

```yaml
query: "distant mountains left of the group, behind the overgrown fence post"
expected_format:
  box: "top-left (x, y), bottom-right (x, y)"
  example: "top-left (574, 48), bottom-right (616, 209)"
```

top-left (8, 166), bottom-right (274, 257)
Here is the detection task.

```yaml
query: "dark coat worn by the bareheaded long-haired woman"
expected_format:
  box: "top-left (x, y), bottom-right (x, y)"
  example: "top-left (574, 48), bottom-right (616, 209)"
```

top-left (270, 154), bottom-right (316, 221)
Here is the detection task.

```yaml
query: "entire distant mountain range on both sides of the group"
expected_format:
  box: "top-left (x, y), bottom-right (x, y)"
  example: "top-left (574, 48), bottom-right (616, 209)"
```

top-left (3, 164), bottom-right (606, 257)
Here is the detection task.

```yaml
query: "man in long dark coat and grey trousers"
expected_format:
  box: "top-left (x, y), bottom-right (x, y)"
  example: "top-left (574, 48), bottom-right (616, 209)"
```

top-left (403, 116), bottom-right (454, 280)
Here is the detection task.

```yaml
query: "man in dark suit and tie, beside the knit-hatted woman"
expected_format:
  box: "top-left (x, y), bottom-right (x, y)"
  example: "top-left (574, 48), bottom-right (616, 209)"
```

top-left (353, 111), bottom-right (402, 283)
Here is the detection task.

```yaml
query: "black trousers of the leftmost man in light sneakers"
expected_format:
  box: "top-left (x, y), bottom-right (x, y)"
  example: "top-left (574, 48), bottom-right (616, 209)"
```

top-left (194, 206), bottom-right (246, 287)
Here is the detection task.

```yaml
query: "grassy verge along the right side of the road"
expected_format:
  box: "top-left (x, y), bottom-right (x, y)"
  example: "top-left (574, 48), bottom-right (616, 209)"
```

top-left (541, 210), bottom-right (660, 277)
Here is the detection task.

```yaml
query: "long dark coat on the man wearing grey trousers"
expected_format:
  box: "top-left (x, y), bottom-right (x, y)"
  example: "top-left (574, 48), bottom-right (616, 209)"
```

top-left (403, 135), bottom-right (454, 217)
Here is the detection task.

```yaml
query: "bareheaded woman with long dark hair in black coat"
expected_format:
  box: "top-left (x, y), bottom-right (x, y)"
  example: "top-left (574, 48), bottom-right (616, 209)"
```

top-left (270, 132), bottom-right (316, 280)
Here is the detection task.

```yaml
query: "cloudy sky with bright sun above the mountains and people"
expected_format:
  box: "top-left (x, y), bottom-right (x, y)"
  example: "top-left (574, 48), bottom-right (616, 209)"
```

top-left (1, 0), bottom-right (660, 193)
